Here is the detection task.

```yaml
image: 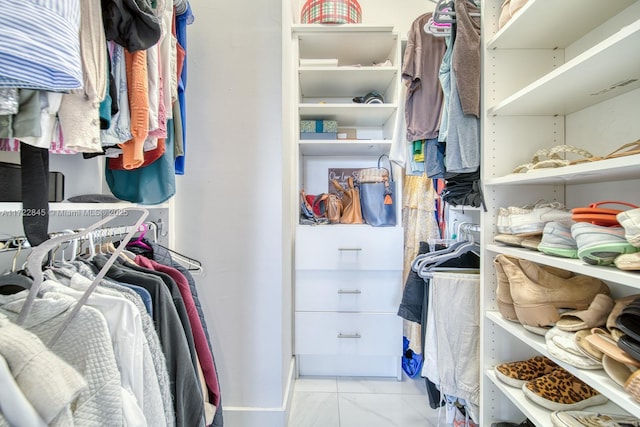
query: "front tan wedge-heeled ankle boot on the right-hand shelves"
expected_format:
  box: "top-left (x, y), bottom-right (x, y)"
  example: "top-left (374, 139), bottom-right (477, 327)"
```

top-left (501, 258), bottom-right (611, 326)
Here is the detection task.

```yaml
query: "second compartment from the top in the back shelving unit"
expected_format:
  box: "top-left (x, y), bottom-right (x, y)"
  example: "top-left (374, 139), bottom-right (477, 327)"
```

top-left (298, 67), bottom-right (398, 98)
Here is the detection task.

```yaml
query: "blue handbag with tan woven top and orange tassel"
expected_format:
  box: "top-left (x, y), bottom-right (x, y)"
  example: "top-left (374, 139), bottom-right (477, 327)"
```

top-left (357, 154), bottom-right (397, 227)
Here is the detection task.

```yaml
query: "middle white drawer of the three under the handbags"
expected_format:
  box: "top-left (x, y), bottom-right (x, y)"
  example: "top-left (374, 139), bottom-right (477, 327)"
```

top-left (295, 270), bottom-right (402, 314)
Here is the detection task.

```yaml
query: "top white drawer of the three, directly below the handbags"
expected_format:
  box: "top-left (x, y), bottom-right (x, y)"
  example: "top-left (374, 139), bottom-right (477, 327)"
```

top-left (296, 224), bottom-right (404, 270)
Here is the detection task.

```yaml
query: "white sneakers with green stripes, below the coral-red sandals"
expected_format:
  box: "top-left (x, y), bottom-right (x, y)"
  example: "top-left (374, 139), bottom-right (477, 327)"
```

top-left (571, 222), bottom-right (640, 265)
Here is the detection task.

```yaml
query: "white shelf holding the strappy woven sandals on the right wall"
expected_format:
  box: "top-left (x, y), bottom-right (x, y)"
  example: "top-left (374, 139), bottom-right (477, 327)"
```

top-left (484, 155), bottom-right (640, 186)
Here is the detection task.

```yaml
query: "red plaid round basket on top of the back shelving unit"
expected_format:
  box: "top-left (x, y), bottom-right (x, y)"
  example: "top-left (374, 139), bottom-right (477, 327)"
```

top-left (300, 0), bottom-right (362, 24)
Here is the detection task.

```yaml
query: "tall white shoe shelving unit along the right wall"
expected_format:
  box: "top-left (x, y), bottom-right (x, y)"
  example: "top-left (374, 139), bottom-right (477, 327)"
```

top-left (480, 0), bottom-right (640, 426)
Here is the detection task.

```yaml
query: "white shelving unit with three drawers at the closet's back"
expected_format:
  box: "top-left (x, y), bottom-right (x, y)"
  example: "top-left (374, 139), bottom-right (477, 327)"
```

top-left (285, 24), bottom-right (404, 379)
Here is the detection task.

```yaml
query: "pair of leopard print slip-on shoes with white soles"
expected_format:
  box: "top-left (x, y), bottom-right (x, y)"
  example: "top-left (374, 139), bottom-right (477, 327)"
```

top-left (494, 356), bottom-right (608, 411)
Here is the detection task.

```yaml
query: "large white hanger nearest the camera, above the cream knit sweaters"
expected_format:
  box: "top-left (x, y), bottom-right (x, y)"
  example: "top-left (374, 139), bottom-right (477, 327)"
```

top-left (15, 207), bottom-right (149, 347)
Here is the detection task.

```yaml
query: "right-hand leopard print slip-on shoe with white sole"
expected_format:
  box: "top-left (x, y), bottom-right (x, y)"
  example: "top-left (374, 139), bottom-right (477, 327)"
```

top-left (522, 367), bottom-right (608, 411)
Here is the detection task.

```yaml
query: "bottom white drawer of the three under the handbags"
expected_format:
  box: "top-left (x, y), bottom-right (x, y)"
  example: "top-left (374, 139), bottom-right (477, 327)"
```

top-left (295, 312), bottom-right (402, 356)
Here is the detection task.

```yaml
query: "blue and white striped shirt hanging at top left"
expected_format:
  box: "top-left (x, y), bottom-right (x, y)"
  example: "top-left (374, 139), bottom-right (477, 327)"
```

top-left (0, 0), bottom-right (83, 92)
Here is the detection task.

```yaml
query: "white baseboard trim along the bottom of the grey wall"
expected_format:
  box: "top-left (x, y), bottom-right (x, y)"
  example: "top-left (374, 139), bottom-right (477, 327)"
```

top-left (223, 357), bottom-right (296, 427)
